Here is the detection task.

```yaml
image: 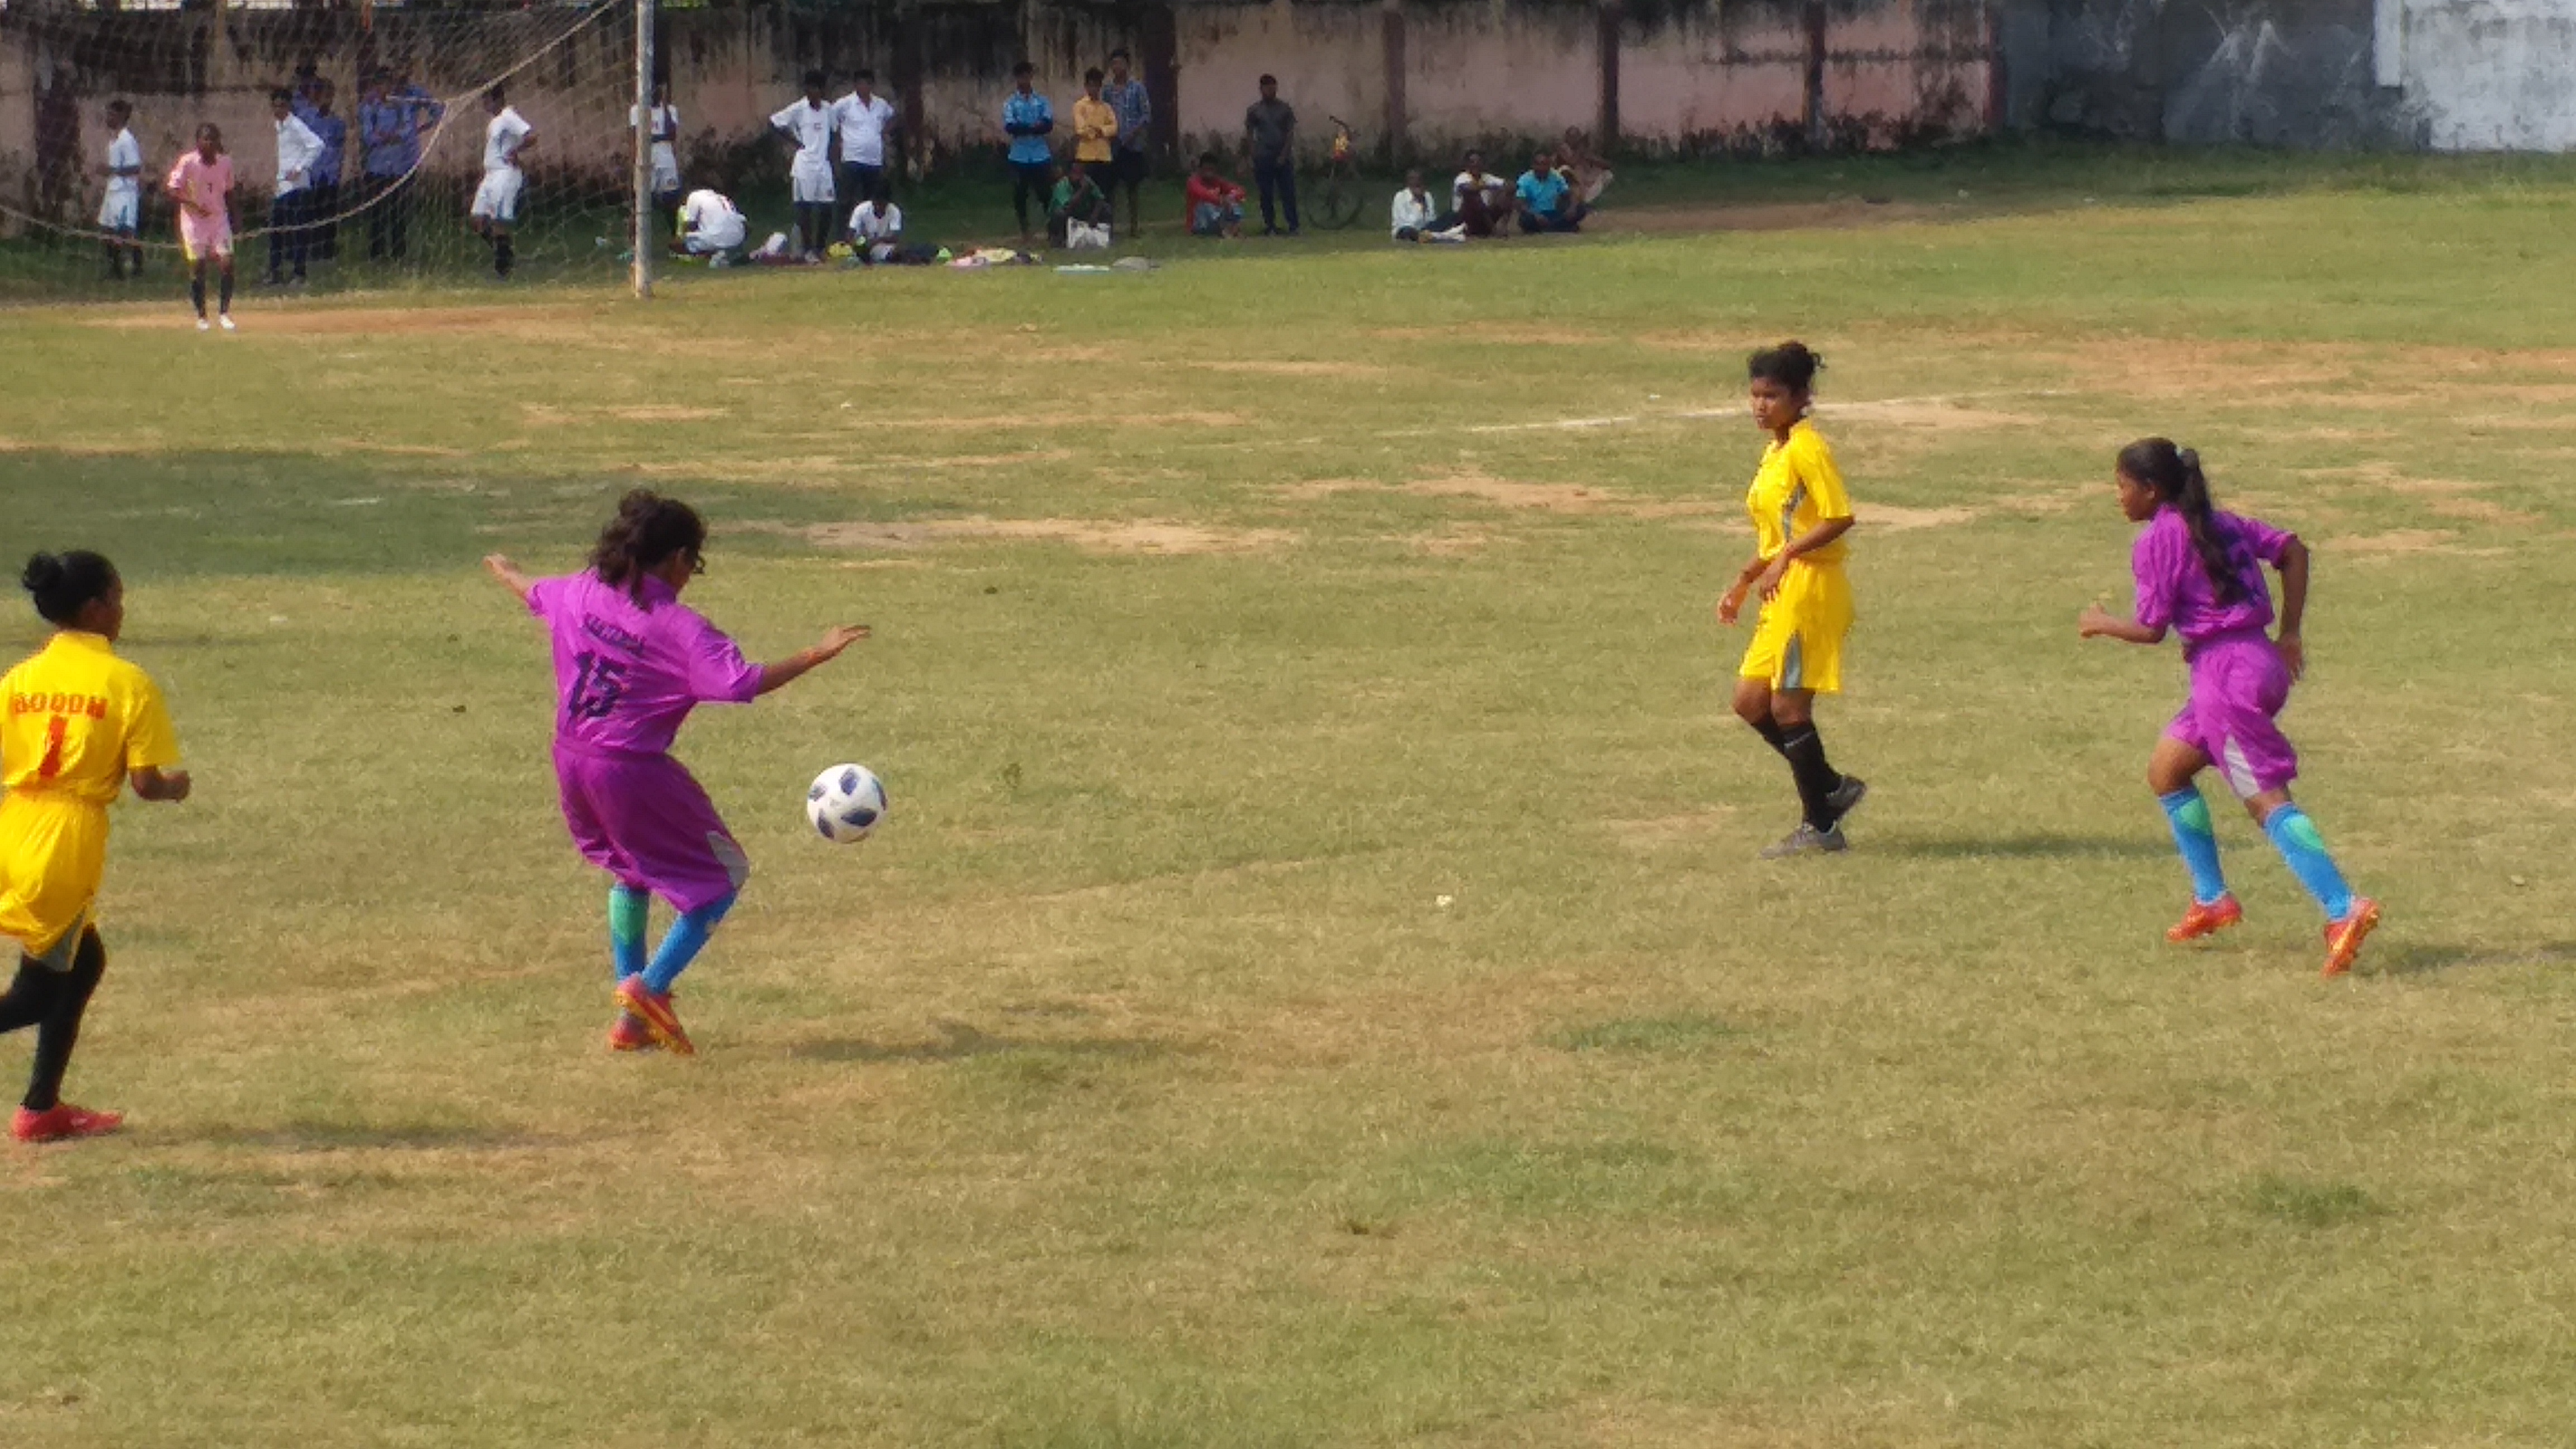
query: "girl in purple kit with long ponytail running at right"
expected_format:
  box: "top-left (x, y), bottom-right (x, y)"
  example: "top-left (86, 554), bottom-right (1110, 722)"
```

top-left (2076, 438), bottom-right (2380, 977)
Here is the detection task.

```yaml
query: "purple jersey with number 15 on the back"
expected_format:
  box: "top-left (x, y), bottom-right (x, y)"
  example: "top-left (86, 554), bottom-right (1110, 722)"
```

top-left (528, 572), bottom-right (760, 755)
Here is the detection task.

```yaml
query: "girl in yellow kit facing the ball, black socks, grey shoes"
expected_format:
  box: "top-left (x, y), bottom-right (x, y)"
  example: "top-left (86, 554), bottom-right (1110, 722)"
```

top-left (1718, 343), bottom-right (1870, 861)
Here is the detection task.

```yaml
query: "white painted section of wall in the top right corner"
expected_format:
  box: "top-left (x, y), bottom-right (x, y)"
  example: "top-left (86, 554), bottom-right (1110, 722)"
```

top-left (2373, 0), bottom-right (2576, 152)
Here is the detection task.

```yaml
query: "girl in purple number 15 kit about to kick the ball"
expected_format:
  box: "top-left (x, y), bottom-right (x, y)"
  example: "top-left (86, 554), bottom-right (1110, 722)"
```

top-left (484, 490), bottom-right (868, 1054)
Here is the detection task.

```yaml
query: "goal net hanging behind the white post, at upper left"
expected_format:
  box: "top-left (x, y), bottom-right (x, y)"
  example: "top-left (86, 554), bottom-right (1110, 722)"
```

top-left (0, 0), bottom-right (636, 302)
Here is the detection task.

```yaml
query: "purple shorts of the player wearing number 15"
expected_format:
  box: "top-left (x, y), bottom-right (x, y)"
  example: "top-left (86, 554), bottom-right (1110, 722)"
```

top-left (554, 740), bottom-right (752, 910)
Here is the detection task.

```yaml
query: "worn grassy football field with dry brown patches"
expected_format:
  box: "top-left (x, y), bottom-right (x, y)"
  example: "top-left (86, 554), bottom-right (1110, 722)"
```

top-left (0, 157), bottom-right (2576, 1449)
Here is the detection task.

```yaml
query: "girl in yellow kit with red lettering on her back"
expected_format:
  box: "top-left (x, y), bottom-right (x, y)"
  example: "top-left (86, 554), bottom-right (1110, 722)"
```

top-left (0, 552), bottom-right (188, 1142)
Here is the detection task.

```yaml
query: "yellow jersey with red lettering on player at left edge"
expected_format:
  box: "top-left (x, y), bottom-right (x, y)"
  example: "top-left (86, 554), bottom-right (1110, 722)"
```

top-left (0, 629), bottom-right (181, 807)
